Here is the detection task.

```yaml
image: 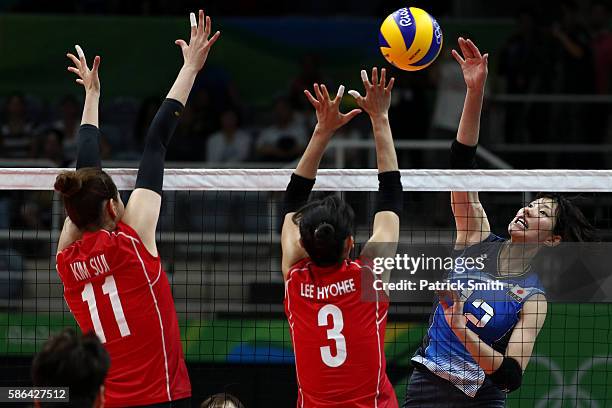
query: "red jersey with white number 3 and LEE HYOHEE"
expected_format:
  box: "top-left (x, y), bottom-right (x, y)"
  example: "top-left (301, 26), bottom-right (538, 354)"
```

top-left (285, 258), bottom-right (398, 408)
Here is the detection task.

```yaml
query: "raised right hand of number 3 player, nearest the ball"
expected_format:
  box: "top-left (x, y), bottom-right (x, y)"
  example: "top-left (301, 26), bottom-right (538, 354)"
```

top-left (349, 67), bottom-right (395, 118)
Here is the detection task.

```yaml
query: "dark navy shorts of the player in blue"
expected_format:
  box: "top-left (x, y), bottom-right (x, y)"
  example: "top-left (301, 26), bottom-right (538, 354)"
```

top-left (402, 367), bottom-right (506, 408)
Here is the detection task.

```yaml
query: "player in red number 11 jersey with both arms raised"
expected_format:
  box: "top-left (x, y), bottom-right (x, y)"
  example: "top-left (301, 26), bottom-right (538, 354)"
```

top-left (55, 10), bottom-right (220, 407)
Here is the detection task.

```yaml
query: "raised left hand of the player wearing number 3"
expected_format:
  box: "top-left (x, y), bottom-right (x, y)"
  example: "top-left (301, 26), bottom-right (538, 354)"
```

top-left (304, 84), bottom-right (361, 135)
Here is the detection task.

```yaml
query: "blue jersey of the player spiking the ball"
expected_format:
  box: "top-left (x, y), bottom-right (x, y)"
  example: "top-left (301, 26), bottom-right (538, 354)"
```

top-left (412, 234), bottom-right (544, 397)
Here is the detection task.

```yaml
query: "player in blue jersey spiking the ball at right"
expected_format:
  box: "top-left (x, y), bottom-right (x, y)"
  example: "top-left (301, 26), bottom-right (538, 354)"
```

top-left (404, 38), bottom-right (594, 408)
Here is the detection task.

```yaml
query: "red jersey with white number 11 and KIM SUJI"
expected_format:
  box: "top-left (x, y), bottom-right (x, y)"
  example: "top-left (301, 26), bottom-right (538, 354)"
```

top-left (57, 222), bottom-right (191, 407)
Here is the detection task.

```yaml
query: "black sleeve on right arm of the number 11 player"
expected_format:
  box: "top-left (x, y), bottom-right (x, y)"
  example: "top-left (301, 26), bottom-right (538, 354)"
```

top-left (136, 99), bottom-right (184, 195)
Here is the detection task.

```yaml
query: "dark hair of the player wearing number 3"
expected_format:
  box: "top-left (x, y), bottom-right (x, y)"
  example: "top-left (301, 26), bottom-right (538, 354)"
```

top-left (293, 196), bottom-right (355, 266)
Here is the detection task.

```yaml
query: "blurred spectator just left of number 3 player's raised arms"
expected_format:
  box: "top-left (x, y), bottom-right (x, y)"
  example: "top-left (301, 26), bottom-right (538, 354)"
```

top-left (256, 97), bottom-right (308, 161)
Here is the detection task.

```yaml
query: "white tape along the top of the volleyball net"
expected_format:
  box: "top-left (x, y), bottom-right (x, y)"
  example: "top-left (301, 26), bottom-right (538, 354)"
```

top-left (0, 168), bottom-right (612, 192)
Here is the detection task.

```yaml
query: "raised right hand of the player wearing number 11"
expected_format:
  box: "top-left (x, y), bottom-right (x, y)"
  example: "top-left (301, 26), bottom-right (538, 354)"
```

top-left (174, 10), bottom-right (221, 72)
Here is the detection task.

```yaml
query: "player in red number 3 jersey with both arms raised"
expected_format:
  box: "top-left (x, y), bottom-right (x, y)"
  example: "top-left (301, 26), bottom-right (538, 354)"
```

top-left (281, 68), bottom-right (402, 408)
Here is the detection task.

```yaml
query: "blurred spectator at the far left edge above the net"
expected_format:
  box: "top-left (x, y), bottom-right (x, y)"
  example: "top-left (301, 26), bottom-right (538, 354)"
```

top-left (0, 94), bottom-right (34, 159)
